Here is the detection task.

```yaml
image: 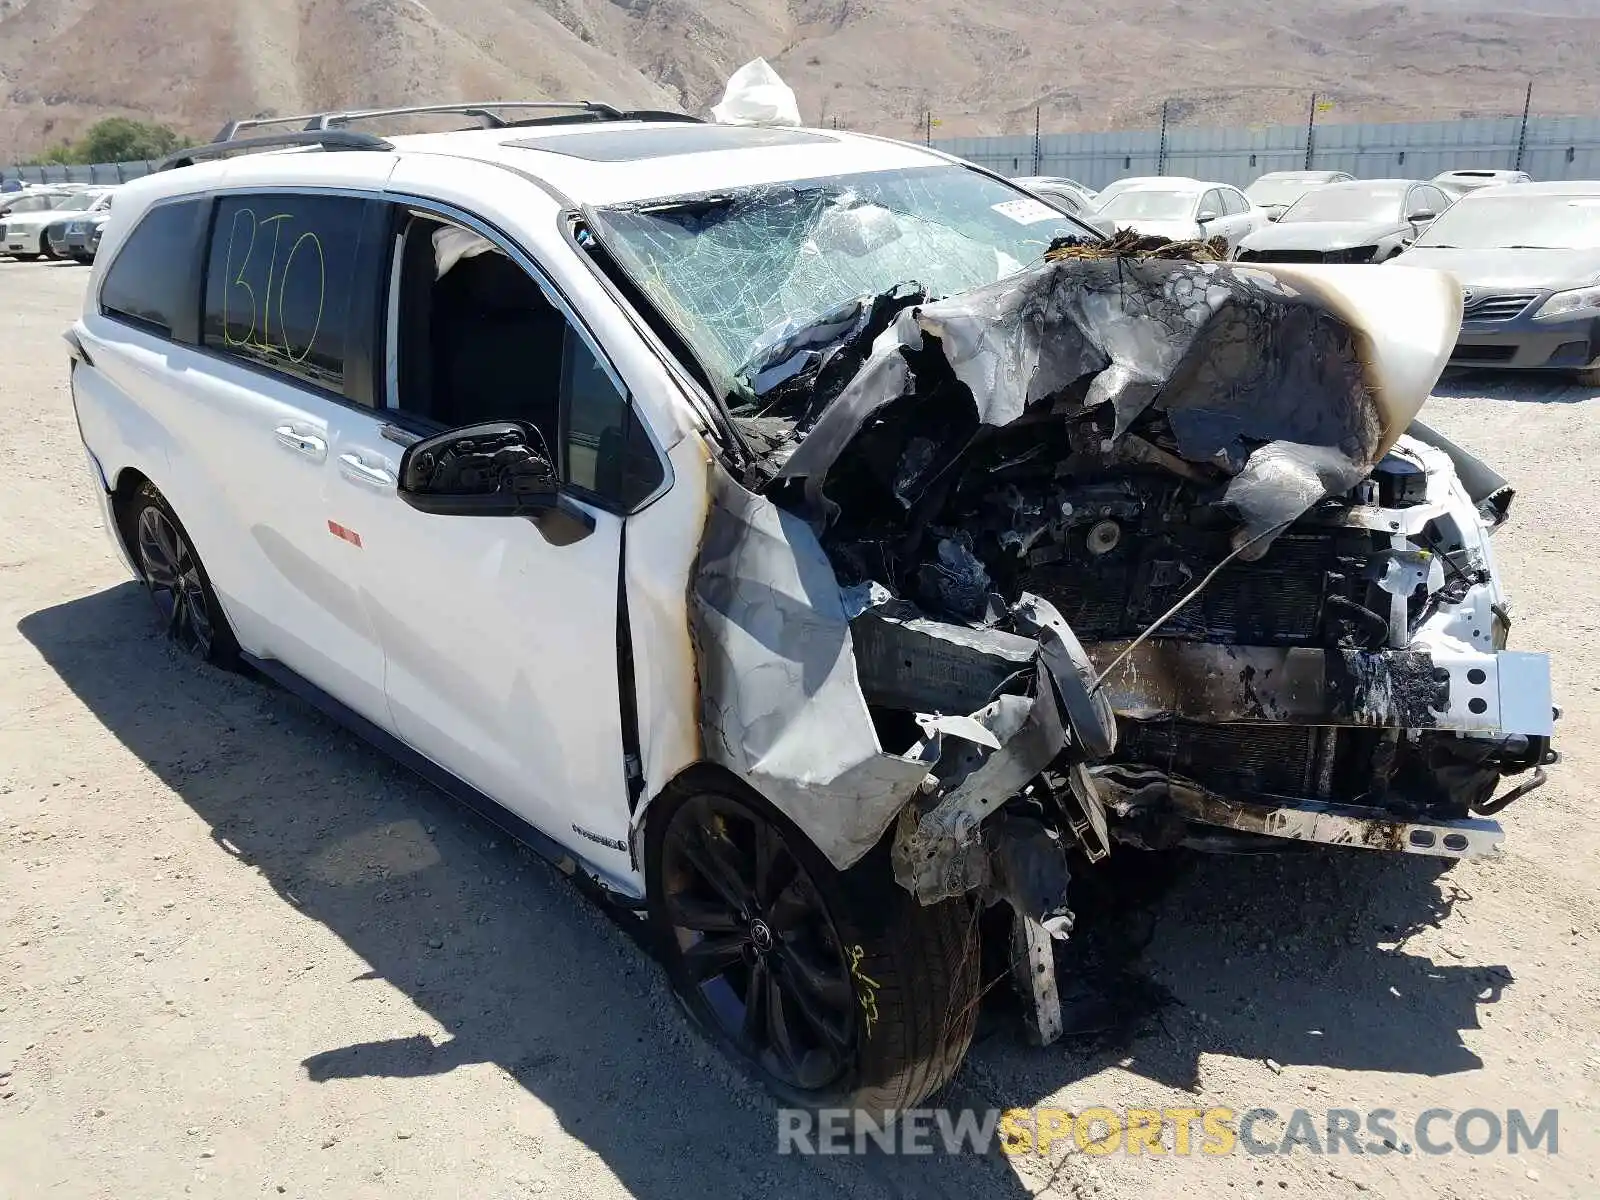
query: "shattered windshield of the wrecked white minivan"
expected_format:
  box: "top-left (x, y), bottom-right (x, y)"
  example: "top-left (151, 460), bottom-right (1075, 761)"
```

top-left (595, 166), bottom-right (1091, 392)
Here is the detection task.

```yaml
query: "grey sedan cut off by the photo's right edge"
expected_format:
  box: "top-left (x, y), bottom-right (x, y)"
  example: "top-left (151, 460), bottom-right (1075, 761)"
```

top-left (1394, 181), bottom-right (1600, 386)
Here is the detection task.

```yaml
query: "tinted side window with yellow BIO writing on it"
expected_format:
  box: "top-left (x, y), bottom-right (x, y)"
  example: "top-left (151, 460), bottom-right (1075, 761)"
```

top-left (203, 194), bottom-right (366, 392)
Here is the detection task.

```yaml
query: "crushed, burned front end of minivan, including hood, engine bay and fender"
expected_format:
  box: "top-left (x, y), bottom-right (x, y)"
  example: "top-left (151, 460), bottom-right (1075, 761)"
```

top-left (691, 243), bottom-right (1554, 1043)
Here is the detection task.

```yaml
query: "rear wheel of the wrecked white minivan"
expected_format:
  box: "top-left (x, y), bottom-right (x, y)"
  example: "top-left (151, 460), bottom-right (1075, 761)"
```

top-left (123, 480), bottom-right (238, 669)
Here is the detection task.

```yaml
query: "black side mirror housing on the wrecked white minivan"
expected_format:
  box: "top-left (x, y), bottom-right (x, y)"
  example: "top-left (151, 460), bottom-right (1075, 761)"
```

top-left (395, 421), bottom-right (560, 517)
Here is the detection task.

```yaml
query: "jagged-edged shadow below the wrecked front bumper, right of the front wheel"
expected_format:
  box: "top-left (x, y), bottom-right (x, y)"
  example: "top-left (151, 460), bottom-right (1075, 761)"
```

top-left (974, 850), bottom-right (1512, 1107)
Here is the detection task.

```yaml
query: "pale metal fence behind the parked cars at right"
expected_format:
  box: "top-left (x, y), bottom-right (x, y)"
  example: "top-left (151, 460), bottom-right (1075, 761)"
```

top-left (934, 117), bottom-right (1600, 187)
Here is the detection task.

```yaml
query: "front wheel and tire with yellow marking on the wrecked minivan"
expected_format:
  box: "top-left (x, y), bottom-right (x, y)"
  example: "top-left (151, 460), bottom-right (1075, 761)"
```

top-left (645, 781), bottom-right (978, 1115)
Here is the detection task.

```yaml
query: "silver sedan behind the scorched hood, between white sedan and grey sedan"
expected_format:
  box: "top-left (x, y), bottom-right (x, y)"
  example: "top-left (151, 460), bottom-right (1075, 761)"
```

top-left (1237, 179), bottom-right (1450, 262)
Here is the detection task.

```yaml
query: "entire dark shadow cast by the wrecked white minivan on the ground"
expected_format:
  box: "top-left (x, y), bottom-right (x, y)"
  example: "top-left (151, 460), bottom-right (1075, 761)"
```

top-left (19, 584), bottom-right (1510, 1200)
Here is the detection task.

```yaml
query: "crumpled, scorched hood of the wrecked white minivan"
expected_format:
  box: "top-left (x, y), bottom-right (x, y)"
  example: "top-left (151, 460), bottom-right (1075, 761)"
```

top-left (779, 258), bottom-right (1461, 558)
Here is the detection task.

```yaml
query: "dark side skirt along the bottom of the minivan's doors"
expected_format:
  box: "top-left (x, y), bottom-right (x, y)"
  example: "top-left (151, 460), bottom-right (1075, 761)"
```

top-left (240, 651), bottom-right (645, 912)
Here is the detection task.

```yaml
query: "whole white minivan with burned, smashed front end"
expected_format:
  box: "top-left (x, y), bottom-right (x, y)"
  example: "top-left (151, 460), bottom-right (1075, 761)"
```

top-left (67, 104), bottom-right (1554, 1110)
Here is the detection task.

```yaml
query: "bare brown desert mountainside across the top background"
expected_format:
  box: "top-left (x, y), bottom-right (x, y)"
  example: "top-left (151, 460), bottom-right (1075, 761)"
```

top-left (0, 0), bottom-right (1600, 162)
